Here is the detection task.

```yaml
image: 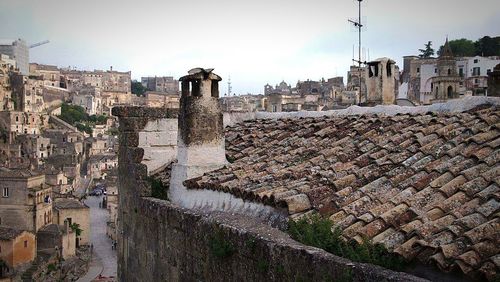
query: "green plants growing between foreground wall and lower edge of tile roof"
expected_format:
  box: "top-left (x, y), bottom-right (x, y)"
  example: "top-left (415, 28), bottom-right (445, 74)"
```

top-left (288, 216), bottom-right (406, 270)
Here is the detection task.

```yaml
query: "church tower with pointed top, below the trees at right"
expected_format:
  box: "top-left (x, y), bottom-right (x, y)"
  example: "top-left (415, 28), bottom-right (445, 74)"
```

top-left (431, 38), bottom-right (461, 103)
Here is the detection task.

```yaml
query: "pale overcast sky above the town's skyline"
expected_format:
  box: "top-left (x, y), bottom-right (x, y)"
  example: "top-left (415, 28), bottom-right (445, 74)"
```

top-left (0, 0), bottom-right (500, 94)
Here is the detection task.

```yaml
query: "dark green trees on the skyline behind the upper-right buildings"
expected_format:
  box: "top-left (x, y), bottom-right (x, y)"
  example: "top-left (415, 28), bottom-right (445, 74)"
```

top-left (437, 36), bottom-right (500, 57)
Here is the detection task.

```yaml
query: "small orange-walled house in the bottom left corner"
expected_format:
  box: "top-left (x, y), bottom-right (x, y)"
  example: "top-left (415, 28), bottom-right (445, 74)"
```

top-left (0, 226), bottom-right (36, 270)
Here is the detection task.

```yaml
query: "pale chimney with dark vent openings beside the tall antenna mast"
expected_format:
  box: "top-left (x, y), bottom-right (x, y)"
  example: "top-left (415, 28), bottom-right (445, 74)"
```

top-left (364, 58), bottom-right (399, 105)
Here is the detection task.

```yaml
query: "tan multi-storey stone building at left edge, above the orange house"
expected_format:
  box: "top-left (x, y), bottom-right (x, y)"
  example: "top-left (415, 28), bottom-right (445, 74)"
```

top-left (0, 169), bottom-right (52, 233)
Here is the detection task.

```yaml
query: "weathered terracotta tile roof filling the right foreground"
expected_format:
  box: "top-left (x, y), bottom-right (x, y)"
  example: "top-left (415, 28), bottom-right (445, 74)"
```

top-left (185, 106), bottom-right (500, 279)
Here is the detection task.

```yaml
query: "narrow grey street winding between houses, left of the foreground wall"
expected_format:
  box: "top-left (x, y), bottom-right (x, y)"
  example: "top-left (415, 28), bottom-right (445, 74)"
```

top-left (78, 196), bottom-right (117, 282)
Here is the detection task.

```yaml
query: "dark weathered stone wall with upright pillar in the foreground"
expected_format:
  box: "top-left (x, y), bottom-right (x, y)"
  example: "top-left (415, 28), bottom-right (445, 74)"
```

top-left (113, 107), bottom-right (421, 281)
